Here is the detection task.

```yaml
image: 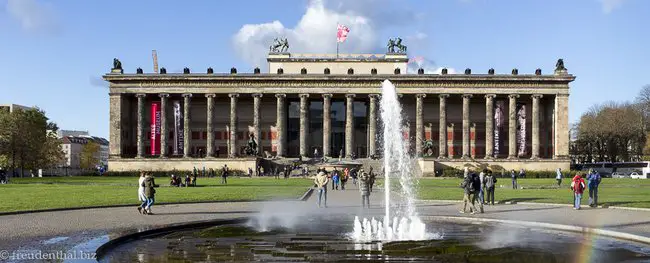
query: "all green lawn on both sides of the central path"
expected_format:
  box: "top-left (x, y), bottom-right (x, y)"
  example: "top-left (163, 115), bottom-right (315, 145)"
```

top-left (0, 176), bottom-right (650, 213)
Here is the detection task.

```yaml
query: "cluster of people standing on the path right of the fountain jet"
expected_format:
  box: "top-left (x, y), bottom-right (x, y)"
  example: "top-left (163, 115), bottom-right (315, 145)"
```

top-left (460, 168), bottom-right (497, 214)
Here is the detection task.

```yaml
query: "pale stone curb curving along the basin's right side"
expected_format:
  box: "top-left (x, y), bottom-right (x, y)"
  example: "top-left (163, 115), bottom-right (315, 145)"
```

top-left (423, 216), bottom-right (650, 244)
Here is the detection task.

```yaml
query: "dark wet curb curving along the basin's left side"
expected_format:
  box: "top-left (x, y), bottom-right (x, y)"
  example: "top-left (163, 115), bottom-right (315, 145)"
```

top-left (95, 218), bottom-right (248, 261)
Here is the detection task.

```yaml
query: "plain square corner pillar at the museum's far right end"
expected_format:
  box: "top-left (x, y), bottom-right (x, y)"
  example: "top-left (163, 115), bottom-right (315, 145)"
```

top-left (553, 94), bottom-right (569, 159)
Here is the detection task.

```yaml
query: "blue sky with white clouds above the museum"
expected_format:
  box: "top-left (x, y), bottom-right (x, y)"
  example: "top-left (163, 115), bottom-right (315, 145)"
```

top-left (0, 0), bottom-right (650, 138)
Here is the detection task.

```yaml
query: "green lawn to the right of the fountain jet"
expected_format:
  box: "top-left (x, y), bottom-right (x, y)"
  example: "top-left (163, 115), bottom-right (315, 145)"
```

top-left (418, 178), bottom-right (650, 208)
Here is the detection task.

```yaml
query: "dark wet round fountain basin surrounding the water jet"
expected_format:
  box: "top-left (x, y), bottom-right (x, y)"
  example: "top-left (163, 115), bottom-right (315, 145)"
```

top-left (100, 216), bottom-right (650, 262)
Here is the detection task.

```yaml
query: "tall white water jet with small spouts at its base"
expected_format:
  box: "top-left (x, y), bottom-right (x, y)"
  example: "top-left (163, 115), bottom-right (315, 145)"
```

top-left (352, 80), bottom-right (426, 241)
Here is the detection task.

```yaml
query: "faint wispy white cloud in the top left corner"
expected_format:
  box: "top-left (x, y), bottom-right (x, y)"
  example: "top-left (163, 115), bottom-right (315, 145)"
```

top-left (6, 0), bottom-right (60, 33)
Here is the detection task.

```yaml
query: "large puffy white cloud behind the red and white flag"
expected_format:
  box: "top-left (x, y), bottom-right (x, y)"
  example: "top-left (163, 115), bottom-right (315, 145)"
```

top-left (232, 0), bottom-right (426, 68)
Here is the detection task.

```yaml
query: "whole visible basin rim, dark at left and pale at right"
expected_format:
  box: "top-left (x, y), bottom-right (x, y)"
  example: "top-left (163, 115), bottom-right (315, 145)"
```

top-left (95, 216), bottom-right (650, 260)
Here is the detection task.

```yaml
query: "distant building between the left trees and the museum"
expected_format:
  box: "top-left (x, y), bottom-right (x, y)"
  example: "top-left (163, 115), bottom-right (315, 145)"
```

top-left (58, 134), bottom-right (109, 168)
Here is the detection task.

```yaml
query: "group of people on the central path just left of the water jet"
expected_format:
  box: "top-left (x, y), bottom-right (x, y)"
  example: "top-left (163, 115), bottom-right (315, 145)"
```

top-left (314, 167), bottom-right (375, 208)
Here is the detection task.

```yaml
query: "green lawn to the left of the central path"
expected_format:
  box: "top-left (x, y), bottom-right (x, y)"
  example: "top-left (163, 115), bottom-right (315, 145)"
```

top-left (0, 176), bottom-right (312, 213)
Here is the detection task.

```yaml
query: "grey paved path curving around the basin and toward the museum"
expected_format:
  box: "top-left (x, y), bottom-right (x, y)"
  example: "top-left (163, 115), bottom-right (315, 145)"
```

top-left (0, 183), bottom-right (650, 258)
